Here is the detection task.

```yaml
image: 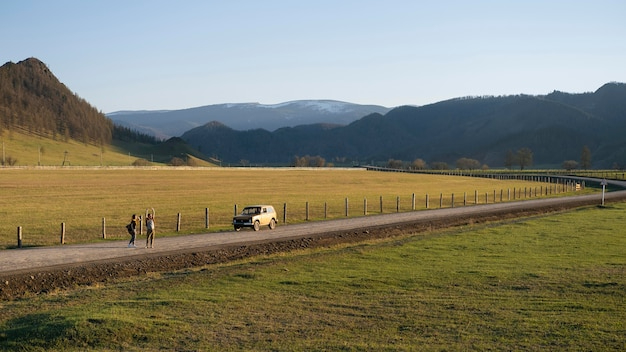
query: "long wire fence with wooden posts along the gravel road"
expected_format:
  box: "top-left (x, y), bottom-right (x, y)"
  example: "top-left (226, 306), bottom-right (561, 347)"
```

top-left (8, 178), bottom-right (585, 248)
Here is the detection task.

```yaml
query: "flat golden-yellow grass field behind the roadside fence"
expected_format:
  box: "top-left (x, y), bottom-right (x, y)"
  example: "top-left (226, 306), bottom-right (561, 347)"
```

top-left (0, 168), bottom-right (592, 248)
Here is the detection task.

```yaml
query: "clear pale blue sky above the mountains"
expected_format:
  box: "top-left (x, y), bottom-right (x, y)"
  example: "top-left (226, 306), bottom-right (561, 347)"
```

top-left (0, 0), bottom-right (626, 113)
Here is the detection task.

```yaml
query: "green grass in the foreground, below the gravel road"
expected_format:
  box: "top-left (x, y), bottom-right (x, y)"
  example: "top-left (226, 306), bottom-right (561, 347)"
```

top-left (0, 203), bottom-right (626, 351)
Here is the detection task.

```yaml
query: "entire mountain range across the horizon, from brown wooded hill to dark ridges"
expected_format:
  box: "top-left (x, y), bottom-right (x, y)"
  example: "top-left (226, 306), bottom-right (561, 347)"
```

top-left (0, 58), bottom-right (626, 169)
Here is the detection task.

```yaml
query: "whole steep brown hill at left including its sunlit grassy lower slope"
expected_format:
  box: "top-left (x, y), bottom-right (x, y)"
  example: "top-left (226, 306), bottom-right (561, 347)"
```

top-left (0, 58), bottom-right (201, 165)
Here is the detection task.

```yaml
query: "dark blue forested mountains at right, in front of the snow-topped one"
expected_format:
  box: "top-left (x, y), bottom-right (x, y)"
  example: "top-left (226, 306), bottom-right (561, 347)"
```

top-left (182, 83), bottom-right (626, 168)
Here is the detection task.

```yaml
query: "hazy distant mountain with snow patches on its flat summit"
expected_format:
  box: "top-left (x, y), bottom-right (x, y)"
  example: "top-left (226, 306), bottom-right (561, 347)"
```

top-left (107, 100), bottom-right (390, 138)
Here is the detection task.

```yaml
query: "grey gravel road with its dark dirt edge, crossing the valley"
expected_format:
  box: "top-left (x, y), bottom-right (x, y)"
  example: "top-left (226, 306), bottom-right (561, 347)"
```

top-left (0, 184), bottom-right (626, 300)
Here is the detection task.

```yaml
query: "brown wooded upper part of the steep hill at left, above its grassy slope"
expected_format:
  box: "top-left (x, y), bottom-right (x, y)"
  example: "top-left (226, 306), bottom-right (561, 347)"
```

top-left (0, 58), bottom-right (113, 144)
